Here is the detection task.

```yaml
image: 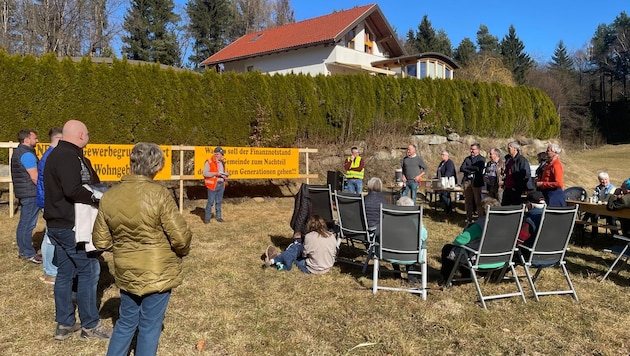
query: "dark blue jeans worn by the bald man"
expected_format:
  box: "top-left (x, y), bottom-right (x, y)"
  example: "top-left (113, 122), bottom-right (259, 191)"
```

top-left (48, 228), bottom-right (101, 329)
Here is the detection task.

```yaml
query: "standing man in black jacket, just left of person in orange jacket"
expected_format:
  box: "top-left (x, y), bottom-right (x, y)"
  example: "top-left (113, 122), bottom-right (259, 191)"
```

top-left (501, 141), bottom-right (531, 206)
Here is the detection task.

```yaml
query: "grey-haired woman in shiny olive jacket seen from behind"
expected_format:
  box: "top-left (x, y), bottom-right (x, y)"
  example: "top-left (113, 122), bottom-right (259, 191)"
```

top-left (92, 142), bottom-right (192, 355)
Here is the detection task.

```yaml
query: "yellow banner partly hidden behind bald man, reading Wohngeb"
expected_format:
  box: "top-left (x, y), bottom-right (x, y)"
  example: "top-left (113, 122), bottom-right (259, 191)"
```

top-left (35, 143), bottom-right (173, 181)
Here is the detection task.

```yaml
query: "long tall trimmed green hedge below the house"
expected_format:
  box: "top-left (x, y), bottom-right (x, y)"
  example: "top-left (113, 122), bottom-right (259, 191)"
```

top-left (0, 52), bottom-right (560, 146)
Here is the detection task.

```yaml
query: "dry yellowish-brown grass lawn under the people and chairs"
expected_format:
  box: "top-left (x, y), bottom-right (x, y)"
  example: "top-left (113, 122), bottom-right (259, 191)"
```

top-left (0, 146), bottom-right (630, 355)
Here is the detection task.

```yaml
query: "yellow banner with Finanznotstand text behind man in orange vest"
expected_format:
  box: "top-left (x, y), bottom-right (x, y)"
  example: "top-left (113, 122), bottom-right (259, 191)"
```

top-left (195, 146), bottom-right (300, 179)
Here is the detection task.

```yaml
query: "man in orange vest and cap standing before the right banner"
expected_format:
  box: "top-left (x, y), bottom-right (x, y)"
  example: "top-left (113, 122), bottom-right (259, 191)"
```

top-left (203, 146), bottom-right (228, 224)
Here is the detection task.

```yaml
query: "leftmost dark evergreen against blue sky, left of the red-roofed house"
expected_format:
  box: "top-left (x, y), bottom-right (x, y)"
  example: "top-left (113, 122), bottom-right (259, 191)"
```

top-left (122, 0), bottom-right (181, 66)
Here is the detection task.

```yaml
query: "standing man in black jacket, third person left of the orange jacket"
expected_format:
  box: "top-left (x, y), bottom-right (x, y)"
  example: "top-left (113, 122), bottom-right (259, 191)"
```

top-left (459, 143), bottom-right (486, 223)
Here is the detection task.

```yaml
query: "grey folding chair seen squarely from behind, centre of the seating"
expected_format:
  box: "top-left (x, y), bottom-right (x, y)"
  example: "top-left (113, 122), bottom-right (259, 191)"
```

top-left (372, 204), bottom-right (427, 300)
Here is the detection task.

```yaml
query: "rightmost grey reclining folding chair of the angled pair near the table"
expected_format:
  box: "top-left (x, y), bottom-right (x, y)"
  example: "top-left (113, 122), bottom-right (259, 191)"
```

top-left (517, 205), bottom-right (578, 301)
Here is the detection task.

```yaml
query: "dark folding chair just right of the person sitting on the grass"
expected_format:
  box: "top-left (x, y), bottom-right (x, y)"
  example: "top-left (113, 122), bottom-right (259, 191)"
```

top-left (335, 191), bottom-right (374, 274)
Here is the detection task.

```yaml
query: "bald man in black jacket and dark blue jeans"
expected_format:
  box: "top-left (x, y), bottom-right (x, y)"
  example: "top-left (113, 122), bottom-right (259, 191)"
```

top-left (44, 120), bottom-right (111, 340)
